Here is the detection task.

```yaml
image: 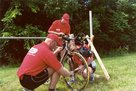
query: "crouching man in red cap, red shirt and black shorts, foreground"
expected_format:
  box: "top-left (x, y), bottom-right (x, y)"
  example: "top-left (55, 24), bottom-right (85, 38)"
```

top-left (17, 34), bottom-right (73, 91)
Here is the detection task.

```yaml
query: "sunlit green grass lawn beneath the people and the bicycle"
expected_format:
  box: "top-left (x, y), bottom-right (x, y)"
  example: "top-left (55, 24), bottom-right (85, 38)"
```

top-left (0, 53), bottom-right (136, 91)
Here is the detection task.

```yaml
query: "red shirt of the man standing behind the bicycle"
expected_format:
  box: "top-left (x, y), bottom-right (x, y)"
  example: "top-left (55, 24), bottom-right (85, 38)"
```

top-left (48, 20), bottom-right (70, 35)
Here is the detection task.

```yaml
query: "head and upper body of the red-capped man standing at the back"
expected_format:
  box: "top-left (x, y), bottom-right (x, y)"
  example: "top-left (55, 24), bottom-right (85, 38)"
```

top-left (48, 13), bottom-right (70, 36)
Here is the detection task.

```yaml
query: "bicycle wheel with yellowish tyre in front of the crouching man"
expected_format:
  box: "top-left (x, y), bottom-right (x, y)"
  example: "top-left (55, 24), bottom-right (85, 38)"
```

top-left (62, 52), bottom-right (89, 91)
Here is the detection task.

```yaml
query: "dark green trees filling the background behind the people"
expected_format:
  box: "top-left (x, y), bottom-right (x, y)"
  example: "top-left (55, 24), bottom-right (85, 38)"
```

top-left (0, 0), bottom-right (136, 63)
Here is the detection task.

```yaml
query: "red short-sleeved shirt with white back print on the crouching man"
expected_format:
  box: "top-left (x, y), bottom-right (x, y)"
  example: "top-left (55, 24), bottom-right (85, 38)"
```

top-left (17, 42), bottom-right (62, 78)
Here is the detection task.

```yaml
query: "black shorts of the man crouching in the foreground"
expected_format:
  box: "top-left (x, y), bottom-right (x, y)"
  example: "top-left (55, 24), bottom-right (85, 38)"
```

top-left (20, 69), bottom-right (49, 90)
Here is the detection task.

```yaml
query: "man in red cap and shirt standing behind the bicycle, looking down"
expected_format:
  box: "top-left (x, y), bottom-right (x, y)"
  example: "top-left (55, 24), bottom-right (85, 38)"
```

top-left (48, 13), bottom-right (70, 59)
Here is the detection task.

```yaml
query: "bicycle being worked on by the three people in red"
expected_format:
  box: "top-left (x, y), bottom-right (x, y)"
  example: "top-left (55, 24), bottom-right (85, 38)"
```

top-left (60, 36), bottom-right (89, 91)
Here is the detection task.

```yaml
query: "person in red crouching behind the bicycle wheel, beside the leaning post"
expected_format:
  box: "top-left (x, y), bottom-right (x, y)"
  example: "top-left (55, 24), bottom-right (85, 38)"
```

top-left (73, 33), bottom-right (96, 82)
